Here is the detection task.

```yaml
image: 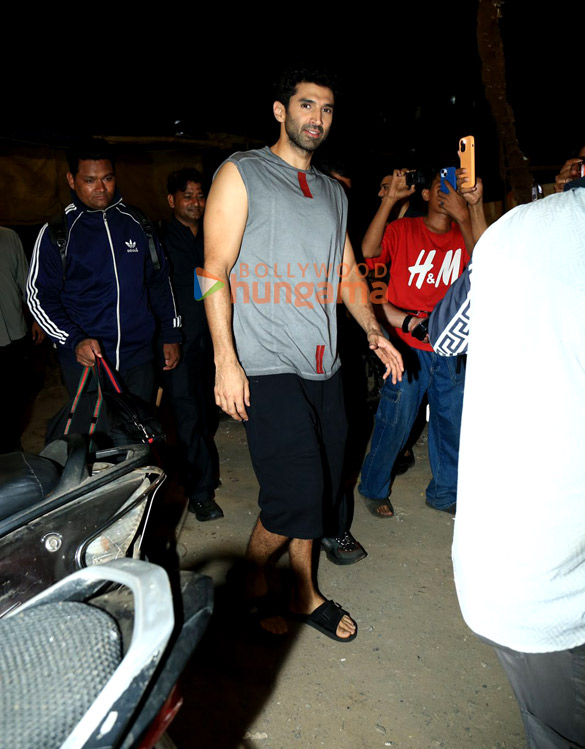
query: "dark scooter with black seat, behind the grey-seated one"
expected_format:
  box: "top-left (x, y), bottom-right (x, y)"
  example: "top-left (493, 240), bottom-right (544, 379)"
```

top-left (0, 435), bottom-right (165, 617)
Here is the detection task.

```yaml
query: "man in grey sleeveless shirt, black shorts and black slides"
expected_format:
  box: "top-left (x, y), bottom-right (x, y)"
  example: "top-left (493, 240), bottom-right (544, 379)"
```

top-left (205, 70), bottom-right (403, 642)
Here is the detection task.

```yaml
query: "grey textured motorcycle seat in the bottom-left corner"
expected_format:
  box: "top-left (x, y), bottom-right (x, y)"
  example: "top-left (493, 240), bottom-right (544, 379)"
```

top-left (0, 601), bottom-right (122, 749)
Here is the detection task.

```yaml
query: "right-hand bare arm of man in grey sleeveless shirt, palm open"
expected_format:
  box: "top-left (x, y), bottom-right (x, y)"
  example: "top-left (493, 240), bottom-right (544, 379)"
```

top-left (341, 235), bottom-right (404, 383)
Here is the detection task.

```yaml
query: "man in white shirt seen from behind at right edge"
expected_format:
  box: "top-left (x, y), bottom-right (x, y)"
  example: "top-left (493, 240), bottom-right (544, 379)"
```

top-left (429, 180), bottom-right (585, 749)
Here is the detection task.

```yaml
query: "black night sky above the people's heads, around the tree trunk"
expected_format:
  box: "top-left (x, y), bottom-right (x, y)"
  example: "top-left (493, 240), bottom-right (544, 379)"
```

top-left (0, 0), bottom-right (585, 205)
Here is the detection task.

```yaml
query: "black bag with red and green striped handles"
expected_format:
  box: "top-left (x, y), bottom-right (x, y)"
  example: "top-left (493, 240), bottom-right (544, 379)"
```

top-left (46, 357), bottom-right (165, 449)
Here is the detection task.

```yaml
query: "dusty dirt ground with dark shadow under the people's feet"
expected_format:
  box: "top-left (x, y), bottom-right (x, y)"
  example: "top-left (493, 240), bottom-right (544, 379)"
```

top-left (23, 360), bottom-right (525, 749)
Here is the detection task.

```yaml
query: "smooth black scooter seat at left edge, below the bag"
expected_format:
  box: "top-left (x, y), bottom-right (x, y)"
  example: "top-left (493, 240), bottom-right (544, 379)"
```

top-left (0, 452), bottom-right (62, 520)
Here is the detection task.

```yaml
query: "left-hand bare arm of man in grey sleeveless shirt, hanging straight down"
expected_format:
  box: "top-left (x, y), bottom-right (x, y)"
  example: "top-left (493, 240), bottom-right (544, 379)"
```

top-left (204, 162), bottom-right (250, 421)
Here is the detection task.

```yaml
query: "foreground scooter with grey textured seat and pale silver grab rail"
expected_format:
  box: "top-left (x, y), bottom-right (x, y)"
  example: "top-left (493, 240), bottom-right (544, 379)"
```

top-left (0, 559), bottom-right (212, 749)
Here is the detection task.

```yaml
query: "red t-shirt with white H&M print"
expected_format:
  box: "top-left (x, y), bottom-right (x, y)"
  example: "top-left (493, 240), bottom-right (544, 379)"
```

top-left (366, 217), bottom-right (469, 351)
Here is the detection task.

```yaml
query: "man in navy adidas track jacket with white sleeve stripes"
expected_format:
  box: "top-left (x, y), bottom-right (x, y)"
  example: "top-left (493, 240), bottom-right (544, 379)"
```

top-left (27, 139), bottom-right (181, 401)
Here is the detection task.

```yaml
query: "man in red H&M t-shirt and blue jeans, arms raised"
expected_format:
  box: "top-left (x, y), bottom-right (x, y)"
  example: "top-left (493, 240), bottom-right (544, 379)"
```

top-left (359, 170), bottom-right (483, 517)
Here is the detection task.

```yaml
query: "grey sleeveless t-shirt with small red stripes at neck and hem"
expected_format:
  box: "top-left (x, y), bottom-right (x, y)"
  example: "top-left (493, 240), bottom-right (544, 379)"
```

top-left (219, 147), bottom-right (347, 380)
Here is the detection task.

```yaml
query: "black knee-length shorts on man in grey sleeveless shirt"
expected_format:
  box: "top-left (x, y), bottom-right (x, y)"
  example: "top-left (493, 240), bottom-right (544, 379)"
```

top-left (246, 371), bottom-right (347, 539)
